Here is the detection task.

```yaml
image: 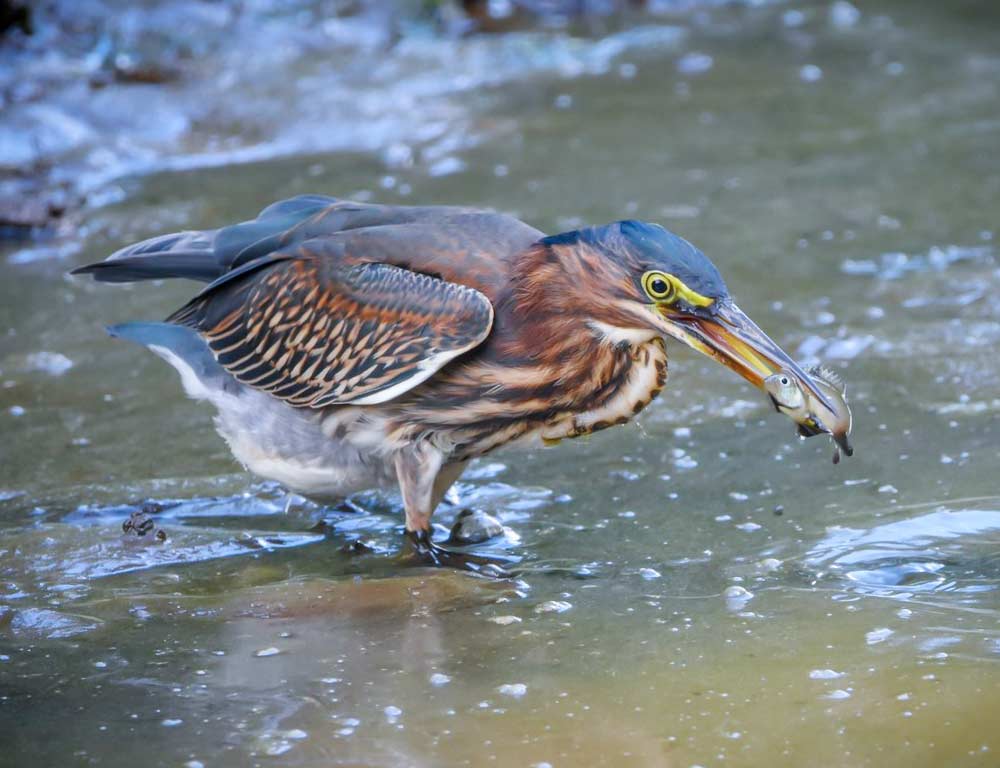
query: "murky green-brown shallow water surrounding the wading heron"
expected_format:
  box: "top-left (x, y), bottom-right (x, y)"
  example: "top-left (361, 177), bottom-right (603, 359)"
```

top-left (0, 0), bottom-right (1000, 766)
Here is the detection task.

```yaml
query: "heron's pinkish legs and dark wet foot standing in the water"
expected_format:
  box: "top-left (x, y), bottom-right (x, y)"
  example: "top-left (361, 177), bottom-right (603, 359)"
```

top-left (396, 443), bottom-right (514, 577)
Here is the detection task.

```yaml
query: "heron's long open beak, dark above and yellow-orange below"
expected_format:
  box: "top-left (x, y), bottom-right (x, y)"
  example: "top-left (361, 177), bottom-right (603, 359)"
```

top-left (661, 301), bottom-right (835, 411)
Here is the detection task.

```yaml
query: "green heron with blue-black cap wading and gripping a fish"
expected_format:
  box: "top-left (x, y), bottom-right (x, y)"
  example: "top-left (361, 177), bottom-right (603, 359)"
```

top-left (75, 196), bottom-right (828, 565)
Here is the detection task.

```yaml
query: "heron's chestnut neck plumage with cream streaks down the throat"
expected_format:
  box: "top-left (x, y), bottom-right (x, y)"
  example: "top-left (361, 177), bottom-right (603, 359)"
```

top-left (398, 243), bottom-right (665, 448)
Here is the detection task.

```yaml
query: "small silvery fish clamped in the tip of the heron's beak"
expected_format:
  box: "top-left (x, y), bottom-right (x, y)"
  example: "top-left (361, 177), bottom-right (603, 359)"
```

top-left (764, 366), bottom-right (854, 464)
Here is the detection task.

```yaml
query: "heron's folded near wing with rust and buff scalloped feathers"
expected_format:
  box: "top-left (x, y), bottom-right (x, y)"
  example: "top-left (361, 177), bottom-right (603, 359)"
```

top-left (168, 250), bottom-right (493, 408)
